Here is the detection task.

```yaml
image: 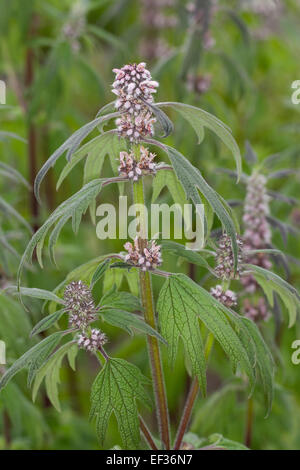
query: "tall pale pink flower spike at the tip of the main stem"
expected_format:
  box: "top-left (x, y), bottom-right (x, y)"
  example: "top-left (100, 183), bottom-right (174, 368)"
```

top-left (112, 62), bottom-right (158, 142)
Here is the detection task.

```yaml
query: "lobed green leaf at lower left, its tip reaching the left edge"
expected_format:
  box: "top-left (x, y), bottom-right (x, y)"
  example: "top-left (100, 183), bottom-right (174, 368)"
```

top-left (0, 331), bottom-right (65, 390)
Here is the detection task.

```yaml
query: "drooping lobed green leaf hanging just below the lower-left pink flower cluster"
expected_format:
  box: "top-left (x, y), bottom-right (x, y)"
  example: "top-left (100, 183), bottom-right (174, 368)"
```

top-left (32, 341), bottom-right (77, 411)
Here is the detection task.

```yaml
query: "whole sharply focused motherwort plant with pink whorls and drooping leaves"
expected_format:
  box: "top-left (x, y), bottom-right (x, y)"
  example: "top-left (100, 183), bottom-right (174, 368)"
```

top-left (0, 63), bottom-right (299, 449)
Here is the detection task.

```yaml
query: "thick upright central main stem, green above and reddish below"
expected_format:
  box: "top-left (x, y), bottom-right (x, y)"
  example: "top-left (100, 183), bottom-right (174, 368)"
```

top-left (133, 146), bottom-right (170, 449)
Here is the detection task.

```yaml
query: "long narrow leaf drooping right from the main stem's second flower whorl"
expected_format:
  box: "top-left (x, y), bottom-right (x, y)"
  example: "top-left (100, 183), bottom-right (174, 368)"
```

top-left (164, 145), bottom-right (238, 267)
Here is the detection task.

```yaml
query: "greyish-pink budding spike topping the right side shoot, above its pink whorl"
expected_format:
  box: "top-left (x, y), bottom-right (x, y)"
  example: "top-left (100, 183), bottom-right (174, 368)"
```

top-left (215, 234), bottom-right (243, 280)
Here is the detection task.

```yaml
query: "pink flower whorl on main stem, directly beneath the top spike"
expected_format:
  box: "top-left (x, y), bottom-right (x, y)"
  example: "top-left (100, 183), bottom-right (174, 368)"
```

top-left (118, 146), bottom-right (156, 181)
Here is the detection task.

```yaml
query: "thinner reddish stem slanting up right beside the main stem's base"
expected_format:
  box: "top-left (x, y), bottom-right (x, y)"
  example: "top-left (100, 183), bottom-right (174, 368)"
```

top-left (174, 333), bottom-right (214, 450)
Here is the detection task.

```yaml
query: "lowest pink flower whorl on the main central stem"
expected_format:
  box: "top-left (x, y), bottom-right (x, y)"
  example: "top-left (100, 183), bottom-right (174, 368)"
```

top-left (124, 237), bottom-right (162, 271)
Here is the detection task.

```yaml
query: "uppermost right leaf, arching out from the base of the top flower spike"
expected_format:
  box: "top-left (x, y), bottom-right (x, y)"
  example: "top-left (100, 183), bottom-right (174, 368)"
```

top-left (156, 102), bottom-right (242, 180)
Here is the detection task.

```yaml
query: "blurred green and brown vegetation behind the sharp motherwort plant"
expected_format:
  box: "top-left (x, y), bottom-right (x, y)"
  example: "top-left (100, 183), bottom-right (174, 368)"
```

top-left (0, 0), bottom-right (300, 449)
